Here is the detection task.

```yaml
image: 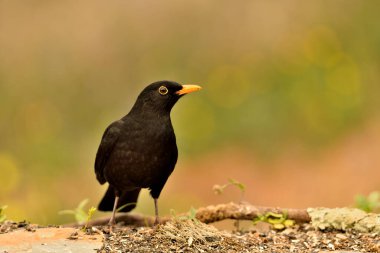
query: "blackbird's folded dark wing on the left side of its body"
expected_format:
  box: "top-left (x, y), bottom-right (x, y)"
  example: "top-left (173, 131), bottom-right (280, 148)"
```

top-left (95, 120), bottom-right (122, 184)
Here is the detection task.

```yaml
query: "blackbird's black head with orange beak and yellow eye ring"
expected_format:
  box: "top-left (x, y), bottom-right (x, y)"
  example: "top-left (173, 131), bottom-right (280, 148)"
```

top-left (132, 81), bottom-right (201, 113)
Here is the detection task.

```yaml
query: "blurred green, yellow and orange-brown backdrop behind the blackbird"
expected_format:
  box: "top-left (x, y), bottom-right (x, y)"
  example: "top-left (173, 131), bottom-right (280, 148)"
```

top-left (0, 0), bottom-right (380, 224)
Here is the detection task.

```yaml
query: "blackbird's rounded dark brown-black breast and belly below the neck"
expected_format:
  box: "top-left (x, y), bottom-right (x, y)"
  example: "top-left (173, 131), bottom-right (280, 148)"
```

top-left (107, 121), bottom-right (178, 188)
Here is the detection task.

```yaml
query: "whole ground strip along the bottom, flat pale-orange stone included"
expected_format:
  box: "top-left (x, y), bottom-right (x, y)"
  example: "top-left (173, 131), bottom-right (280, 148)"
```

top-left (0, 219), bottom-right (380, 253)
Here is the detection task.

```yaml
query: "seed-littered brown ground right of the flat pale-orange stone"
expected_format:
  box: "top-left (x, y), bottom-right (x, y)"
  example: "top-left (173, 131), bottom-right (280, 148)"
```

top-left (98, 220), bottom-right (380, 253)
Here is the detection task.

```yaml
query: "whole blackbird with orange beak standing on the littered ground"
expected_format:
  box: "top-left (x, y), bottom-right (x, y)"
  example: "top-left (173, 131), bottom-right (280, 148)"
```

top-left (95, 81), bottom-right (201, 225)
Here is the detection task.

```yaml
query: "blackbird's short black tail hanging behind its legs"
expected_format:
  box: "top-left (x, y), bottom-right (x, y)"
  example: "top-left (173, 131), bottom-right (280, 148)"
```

top-left (98, 186), bottom-right (141, 212)
